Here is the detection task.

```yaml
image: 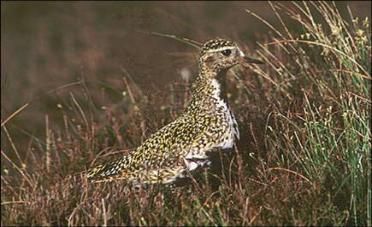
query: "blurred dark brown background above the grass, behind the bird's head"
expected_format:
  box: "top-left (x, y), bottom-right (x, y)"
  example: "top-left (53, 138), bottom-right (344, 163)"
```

top-left (1, 1), bottom-right (371, 149)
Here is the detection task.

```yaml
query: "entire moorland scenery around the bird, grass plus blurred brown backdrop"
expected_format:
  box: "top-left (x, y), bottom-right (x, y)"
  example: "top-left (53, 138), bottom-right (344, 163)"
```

top-left (1, 2), bottom-right (371, 226)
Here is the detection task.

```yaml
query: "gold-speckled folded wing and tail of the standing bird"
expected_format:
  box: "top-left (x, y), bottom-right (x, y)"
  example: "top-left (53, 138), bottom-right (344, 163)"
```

top-left (87, 112), bottom-right (227, 183)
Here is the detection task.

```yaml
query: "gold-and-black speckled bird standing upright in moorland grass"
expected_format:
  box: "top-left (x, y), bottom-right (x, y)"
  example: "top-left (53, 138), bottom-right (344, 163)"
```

top-left (87, 38), bottom-right (263, 185)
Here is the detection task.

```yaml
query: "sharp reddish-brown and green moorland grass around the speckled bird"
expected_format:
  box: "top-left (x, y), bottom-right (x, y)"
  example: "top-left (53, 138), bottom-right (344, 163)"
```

top-left (1, 2), bottom-right (372, 226)
